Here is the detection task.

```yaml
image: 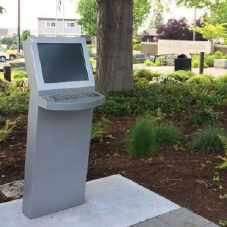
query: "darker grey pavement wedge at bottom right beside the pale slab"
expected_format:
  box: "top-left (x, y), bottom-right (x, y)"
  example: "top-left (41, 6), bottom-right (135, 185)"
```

top-left (131, 208), bottom-right (218, 227)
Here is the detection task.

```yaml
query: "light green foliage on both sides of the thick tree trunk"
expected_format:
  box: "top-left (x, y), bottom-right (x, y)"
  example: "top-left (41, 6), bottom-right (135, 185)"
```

top-left (78, 0), bottom-right (151, 36)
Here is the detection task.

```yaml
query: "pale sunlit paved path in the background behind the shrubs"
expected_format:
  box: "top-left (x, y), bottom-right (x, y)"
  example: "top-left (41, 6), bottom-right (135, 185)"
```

top-left (133, 64), bottom-right (227, 76)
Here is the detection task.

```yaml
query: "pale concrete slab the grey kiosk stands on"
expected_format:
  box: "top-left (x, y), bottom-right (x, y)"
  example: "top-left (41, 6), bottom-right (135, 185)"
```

top-left (0, 175), bottom-right (180, 227)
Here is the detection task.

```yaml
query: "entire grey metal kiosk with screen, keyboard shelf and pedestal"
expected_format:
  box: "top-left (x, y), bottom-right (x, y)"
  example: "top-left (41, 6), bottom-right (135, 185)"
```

top-left (23, 38), bottom-right (104, 218)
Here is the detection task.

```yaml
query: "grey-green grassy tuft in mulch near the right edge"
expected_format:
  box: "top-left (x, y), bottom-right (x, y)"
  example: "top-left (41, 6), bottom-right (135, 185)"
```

top-left (192, 126), bottom-right (224, 154)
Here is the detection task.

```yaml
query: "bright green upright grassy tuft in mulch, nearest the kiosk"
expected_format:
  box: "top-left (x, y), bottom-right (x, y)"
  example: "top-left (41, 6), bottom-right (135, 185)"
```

top-left (127, 119), bottom-right (157, 157)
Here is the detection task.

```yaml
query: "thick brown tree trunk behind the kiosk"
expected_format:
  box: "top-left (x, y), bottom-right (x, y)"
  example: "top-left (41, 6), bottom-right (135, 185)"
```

top-left (96, 0), bottom-right (133, 92)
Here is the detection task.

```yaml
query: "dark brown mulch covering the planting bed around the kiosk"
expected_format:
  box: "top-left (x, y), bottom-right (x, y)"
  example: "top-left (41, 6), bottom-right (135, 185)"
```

top-left (0, 115), bottom-right (227, 223)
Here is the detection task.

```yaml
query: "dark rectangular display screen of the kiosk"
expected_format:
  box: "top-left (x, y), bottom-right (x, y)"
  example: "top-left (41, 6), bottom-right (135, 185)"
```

top-left (38, 43), bottom-right (88, 83)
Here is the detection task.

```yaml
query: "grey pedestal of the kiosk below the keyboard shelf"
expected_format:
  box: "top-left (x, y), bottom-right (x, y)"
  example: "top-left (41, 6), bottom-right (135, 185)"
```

top-left (23, 106), bottom-right (93, 218)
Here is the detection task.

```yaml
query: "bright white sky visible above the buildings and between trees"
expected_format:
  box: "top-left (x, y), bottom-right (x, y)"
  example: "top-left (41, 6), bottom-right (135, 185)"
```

top-left (0, 0), bottom-right (206, 31)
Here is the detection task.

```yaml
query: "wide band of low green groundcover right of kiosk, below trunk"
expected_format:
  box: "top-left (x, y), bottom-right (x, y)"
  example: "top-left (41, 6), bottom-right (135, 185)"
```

top-left (96, 81), bottom-right (227, 116)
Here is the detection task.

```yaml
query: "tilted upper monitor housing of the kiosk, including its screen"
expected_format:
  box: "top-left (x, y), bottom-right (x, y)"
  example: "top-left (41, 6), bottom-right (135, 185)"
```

top-left (24, 37), bottom-right (95, 95)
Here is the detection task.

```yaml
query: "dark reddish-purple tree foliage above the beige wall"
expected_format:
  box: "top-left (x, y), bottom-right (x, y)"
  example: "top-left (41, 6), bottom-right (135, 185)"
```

top-left (157, 18), bottom-right (204, 40)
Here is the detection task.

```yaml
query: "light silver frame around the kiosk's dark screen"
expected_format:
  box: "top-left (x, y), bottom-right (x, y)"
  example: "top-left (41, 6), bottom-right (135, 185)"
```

top-left (29, 37), bottom-right (95, 94)
